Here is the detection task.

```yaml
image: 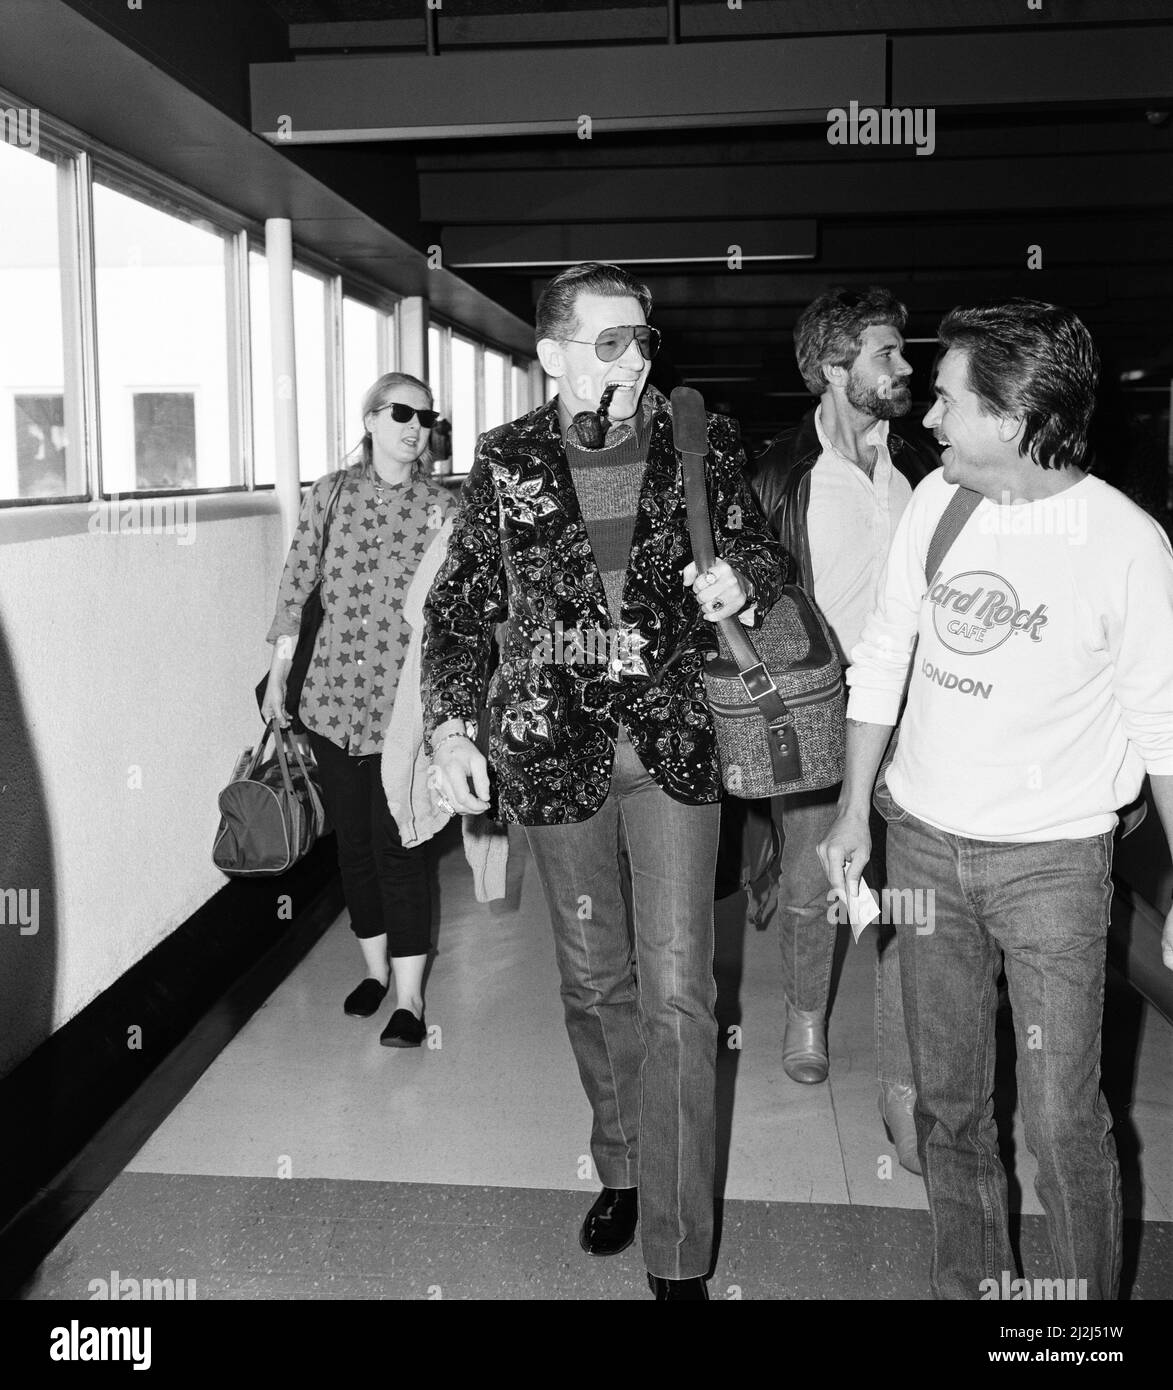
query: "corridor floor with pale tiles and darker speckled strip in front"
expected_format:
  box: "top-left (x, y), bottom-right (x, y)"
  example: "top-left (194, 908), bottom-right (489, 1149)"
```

top-left (16, 817), bottom-right (1173, 1300)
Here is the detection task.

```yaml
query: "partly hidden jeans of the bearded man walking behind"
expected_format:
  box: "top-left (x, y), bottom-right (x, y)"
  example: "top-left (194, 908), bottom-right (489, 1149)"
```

top-left (748, 785), bottom-right (912, 1086)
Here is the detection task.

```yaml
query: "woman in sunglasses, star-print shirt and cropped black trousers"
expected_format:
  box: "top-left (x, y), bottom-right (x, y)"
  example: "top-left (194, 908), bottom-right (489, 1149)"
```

top-left (261, 371), bottom-right (453, 1047)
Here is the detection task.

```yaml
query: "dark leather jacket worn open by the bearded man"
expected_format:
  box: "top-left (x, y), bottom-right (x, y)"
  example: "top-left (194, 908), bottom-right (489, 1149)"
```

top-left (749, 406), bottom-right (941, 595)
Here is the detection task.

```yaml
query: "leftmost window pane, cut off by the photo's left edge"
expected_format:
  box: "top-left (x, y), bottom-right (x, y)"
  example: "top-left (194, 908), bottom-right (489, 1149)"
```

top-left (0, 142), bottom-right (86, 500)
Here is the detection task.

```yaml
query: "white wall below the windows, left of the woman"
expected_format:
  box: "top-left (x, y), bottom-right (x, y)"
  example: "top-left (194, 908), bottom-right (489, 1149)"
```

top-left (0, 498), bottom-right (284, 1073)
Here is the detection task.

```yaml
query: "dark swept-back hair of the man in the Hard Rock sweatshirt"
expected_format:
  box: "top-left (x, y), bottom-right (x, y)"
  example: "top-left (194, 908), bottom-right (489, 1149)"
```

top-left (937, 299), bottom-right (1099, 468)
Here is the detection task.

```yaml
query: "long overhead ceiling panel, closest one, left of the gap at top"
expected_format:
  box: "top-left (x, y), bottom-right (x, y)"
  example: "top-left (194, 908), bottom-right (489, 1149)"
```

top-left (250, 33), bottom-right (887, 145)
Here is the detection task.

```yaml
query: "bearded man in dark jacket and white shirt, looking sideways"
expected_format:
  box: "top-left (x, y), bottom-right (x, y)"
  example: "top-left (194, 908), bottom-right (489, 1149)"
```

top-left (749, 286), bottom-right (937, 1173)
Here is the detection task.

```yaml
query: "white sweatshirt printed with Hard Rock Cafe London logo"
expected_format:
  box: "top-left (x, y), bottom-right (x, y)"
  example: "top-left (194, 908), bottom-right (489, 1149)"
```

top-left (848, 470), bottom-right (1173, 841)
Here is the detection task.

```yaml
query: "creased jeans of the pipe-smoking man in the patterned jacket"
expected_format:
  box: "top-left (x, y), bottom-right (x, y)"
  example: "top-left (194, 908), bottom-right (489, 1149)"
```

top-left (525, 738), bottom-right (720, 1279)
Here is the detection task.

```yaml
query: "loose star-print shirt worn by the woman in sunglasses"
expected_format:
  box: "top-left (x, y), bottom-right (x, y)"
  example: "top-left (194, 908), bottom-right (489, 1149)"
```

top-left (267, 463), bottom-right (454, 756)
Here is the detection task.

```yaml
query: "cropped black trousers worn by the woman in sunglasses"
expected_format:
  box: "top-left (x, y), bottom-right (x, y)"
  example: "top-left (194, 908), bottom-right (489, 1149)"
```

top-left (309, 730), bottom-right (432, 956)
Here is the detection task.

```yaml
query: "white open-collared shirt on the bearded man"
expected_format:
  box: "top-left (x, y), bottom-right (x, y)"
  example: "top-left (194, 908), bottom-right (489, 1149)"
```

top-left (806, 403), bottom-right (912, 660)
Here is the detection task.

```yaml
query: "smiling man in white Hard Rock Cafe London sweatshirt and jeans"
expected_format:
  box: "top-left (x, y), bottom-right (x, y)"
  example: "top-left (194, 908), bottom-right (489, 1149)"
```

top-left (819, 300), bottom-right (1173, 1298)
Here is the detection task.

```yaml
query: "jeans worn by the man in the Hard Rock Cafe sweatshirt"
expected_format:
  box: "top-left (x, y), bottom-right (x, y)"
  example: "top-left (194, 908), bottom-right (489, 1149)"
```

top-left (876, 781), bottom-right (1122, 1298)
